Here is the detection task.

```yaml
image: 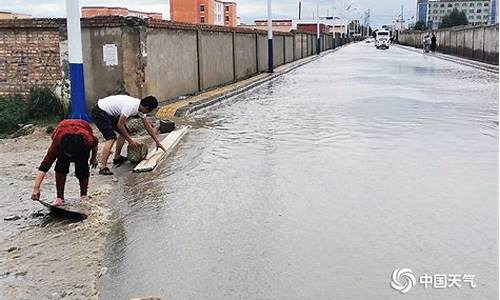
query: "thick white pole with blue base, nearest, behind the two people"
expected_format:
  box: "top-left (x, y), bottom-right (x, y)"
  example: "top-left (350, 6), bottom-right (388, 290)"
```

top-left (66, 0), bottom-right (90, 121)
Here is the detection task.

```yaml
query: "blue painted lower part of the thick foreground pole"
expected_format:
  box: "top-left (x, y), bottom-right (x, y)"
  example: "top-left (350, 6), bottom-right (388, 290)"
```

top-left (69, 63), bottom-right (91, 122)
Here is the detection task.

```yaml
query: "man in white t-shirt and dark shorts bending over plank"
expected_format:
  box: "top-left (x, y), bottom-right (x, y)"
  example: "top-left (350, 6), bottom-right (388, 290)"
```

top-left (92, 95), bottom-right (165, 175)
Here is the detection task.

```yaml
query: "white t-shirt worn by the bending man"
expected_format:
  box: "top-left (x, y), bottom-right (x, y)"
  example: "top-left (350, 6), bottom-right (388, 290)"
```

top-left (97, 95), bottom-right (144, 118)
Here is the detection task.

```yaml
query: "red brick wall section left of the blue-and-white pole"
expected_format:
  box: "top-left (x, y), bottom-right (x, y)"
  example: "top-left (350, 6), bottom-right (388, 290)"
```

top-left (0, 28), bottom-right (62, 95)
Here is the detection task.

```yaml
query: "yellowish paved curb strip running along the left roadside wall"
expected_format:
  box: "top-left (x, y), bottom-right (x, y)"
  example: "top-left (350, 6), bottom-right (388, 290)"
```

top-left (156, 44), bottom-right (350, 119)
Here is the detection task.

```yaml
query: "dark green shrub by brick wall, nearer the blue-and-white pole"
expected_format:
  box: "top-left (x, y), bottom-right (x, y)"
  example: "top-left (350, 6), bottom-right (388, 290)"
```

top-left (27, 88), bottom-right (65, 120)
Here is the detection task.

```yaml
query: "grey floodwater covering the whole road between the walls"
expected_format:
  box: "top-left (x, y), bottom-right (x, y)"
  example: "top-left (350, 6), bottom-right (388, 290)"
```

top-left (101, 43), bottom-right (498, 300)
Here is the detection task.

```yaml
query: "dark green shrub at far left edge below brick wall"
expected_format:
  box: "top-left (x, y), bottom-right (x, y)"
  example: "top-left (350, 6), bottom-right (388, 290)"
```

top-left (0, 95), bottom-right (28, 134)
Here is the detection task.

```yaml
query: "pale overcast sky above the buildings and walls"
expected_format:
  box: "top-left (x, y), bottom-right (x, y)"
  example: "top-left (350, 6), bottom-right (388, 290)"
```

top-left (0, 0), bottom-right (416, 27)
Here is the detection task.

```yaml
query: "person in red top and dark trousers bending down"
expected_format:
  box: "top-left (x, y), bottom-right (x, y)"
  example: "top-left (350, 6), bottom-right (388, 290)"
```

top-left (31, 120), bottom-right (98, 206)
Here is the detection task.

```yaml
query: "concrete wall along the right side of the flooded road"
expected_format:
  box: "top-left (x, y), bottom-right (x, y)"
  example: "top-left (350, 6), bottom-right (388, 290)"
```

top-left (399, 24), bottom-right (498, 65)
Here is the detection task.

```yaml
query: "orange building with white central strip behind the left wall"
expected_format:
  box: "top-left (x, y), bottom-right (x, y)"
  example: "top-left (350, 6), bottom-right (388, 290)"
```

top-left (170, 0), bottom-right (238, 27)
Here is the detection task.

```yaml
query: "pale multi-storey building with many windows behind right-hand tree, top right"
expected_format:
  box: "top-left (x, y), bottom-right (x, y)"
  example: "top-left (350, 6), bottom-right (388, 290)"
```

top-left (427, 0), bottom-right (492, 29)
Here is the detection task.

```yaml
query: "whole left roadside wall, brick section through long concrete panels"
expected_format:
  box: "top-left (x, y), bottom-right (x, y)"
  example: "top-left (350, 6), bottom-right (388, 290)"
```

top-left (0, 17), bottom-right (347, 108)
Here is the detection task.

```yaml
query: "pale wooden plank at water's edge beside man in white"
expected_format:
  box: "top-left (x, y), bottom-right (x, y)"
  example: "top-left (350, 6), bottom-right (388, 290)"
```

top-left (134, 126), bottom-right (189, 173)
